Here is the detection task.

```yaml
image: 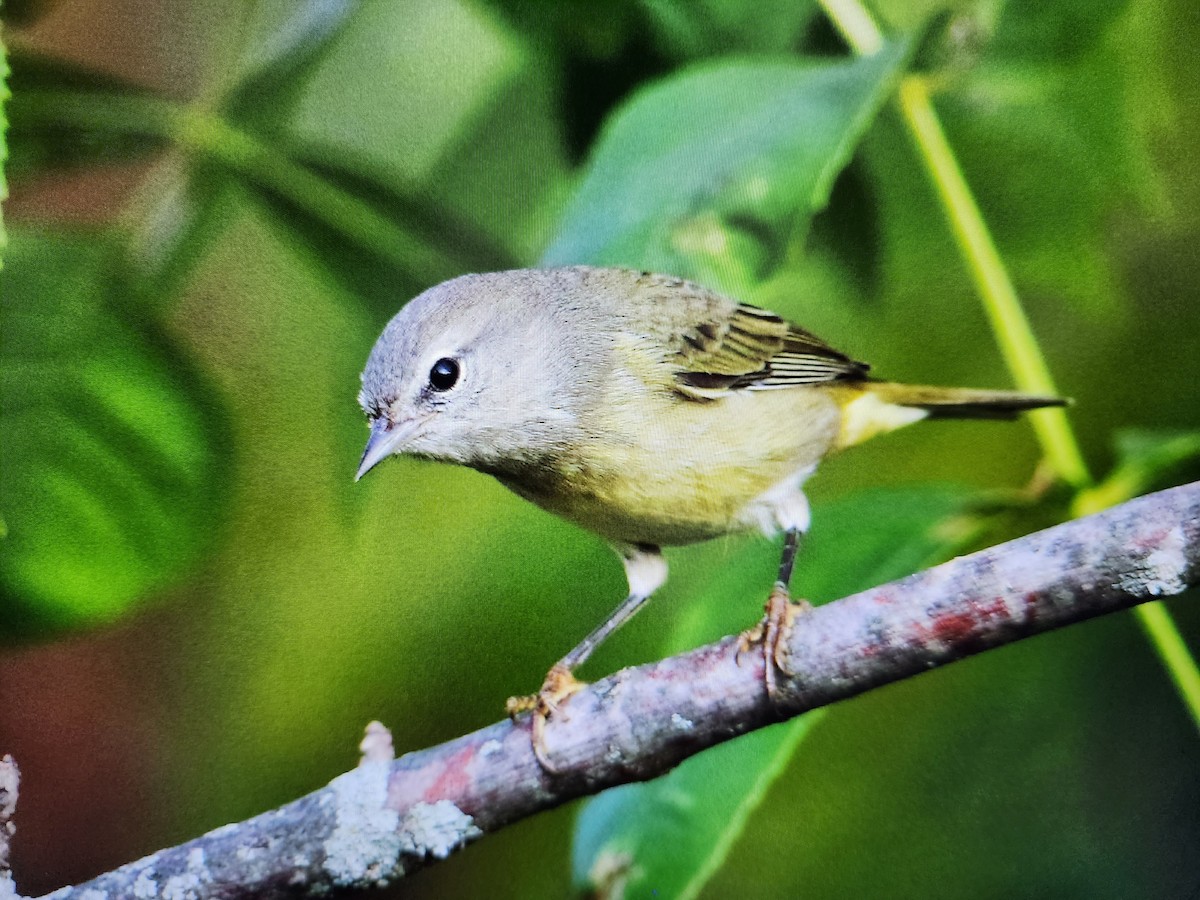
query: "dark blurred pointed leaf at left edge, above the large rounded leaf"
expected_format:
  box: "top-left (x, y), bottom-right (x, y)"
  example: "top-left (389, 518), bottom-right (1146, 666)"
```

top-left (8, 53), bottom-right (168, 180)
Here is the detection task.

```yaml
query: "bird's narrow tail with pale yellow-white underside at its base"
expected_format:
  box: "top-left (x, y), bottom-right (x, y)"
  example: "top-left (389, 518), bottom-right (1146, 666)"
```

top-left (838, 382), bottom-right (1069, 448)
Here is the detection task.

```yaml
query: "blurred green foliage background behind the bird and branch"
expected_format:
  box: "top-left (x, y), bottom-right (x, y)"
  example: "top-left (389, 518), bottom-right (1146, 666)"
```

top-left (0, 0), bottom-right (1200, 898)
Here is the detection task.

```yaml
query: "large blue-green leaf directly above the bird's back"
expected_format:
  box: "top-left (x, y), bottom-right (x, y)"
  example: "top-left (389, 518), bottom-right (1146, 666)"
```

top-left (544, 43), bottom-right (907, 289)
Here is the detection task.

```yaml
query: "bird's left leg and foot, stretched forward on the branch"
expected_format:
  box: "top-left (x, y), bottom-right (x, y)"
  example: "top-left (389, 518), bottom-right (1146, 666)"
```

top-left (508, 544), bottom-right (667, 773)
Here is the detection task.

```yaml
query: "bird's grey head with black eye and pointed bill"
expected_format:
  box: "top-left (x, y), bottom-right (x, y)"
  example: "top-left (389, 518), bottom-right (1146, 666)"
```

top-left (358, 269), bottom-right (604, 478)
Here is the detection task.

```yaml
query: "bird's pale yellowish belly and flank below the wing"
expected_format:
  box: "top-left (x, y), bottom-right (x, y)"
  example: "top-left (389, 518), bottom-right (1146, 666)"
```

top-left (503, 388), bottom-right (840, 545)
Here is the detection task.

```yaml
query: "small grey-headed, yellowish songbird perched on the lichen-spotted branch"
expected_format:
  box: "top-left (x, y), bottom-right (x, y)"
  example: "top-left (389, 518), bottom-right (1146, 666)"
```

top-left (358, 266), bottom-right (1063, 763)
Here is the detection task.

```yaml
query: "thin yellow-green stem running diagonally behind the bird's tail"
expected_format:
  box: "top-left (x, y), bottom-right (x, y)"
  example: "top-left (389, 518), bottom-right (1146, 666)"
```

top-left (821, 0), bottom-right (1200, 728)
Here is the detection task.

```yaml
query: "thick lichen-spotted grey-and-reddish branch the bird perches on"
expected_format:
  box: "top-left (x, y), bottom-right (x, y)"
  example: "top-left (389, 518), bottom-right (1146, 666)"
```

top-left (32, 482), bottom-right (1200, 900)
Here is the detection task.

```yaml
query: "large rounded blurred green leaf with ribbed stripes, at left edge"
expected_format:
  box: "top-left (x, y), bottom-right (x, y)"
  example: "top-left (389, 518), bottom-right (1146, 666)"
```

top-left (0, 230), bottom-right (223, 634)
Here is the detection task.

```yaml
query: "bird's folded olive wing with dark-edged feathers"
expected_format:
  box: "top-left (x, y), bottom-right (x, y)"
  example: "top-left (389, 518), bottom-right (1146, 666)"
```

top-left (674, 304), bottom-right (870, 400)
